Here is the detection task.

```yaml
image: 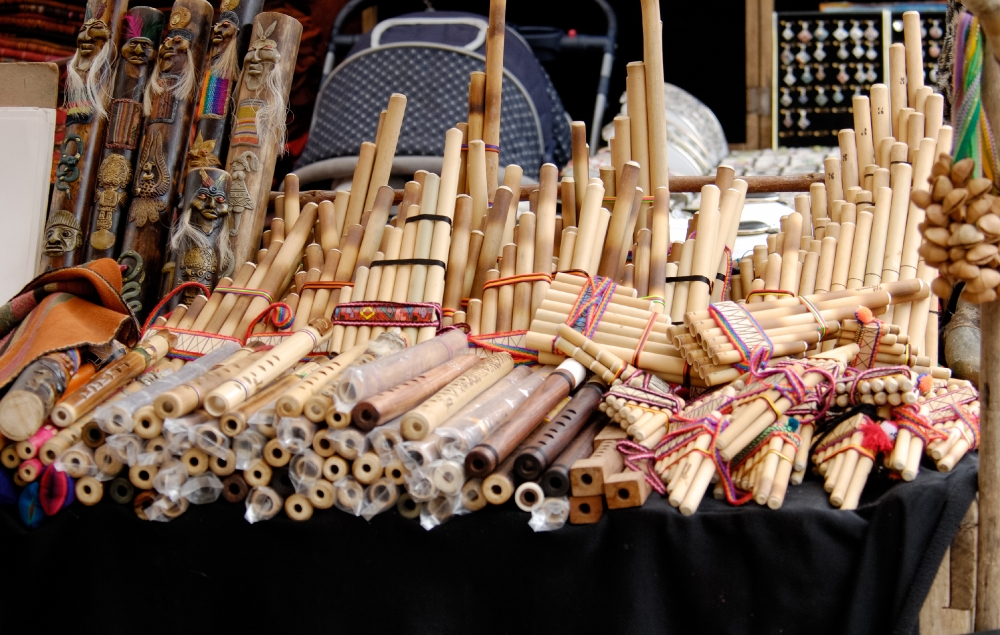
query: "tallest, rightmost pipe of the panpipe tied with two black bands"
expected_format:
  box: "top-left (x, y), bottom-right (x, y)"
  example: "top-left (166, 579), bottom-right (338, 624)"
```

top-left (416, 128), bottom-right (464, 342)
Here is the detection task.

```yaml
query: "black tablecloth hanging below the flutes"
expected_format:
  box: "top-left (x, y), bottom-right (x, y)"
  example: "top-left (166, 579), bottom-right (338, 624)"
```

top-left (0, 455), bottom-right (978, 635)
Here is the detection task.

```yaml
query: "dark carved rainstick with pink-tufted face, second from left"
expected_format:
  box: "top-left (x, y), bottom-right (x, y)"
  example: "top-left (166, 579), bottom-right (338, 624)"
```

top-left (84, 7), bottom-right (167, 260)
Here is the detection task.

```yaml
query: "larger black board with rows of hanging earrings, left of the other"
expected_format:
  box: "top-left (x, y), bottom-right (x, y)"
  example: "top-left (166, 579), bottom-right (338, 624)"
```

top-left (771, 11), bottom-right (891, 148)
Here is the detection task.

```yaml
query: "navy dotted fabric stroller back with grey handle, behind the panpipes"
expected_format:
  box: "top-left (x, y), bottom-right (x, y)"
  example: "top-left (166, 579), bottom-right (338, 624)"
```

top-left (298, 11), bottom-right (570, 178)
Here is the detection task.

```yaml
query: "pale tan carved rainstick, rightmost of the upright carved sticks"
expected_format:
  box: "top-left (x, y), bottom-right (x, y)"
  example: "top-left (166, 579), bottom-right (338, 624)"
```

top-left (226, 13), bottom-right (302, 262)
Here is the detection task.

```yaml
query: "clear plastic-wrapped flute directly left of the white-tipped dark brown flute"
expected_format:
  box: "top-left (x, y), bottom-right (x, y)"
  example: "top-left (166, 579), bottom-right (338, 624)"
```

top-left (434, 373), bottom-right (545, 461)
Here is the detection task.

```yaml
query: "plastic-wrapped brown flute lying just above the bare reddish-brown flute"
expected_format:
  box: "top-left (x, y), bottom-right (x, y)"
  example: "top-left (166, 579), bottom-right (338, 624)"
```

top-left (334, 329), bottom-right (470, 412)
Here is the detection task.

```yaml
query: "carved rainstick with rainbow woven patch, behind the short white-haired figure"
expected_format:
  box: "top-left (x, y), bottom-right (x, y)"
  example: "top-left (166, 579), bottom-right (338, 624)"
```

top-left (187, 0), bottom-right (264, 171)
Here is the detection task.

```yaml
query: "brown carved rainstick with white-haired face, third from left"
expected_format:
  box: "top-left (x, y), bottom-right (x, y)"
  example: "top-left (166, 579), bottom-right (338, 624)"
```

top-left (118, 0), bottom-right (212, 314)
